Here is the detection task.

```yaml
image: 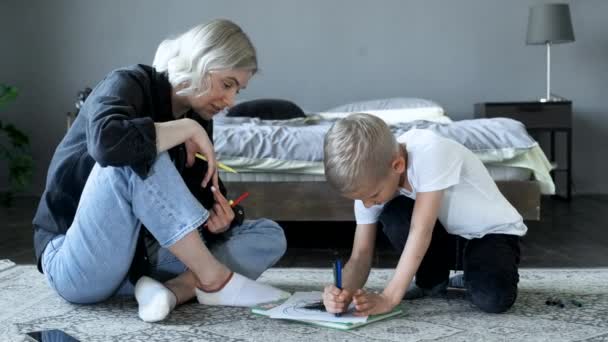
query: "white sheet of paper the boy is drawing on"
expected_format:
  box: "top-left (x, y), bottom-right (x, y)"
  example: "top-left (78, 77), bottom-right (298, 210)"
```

top-left (268, 291), bottom-right (367, 323)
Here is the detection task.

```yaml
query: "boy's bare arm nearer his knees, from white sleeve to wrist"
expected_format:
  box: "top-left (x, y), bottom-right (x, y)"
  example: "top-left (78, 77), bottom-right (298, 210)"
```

top-left (382, 190), bottom-right (443, 305)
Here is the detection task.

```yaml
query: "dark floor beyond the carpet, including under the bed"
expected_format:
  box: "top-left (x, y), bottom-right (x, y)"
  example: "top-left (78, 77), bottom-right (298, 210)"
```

top-left (0, 195), bottom-right (608, 267)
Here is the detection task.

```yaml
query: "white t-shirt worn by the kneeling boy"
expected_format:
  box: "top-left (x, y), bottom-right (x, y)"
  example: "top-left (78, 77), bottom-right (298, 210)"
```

top-left (355, 129), bottom-right (528, 239)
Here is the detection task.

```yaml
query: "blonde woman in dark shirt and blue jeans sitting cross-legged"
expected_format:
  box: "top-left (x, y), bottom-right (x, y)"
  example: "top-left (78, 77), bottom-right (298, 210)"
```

top-left (33, 20), bottom-right (286, 321)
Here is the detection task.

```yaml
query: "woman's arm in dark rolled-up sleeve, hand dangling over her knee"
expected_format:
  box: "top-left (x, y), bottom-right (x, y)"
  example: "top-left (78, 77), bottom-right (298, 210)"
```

top-left (81, 68), bottom-right (217, 186)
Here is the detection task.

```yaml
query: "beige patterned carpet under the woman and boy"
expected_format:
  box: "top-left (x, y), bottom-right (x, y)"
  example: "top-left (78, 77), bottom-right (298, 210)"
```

top-left (0, 260), bottom-right (608, 342)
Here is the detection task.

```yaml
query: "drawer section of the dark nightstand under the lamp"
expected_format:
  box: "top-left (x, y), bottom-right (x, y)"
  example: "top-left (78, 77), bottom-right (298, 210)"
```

top-left (475, 102), bottom-right (572, 128)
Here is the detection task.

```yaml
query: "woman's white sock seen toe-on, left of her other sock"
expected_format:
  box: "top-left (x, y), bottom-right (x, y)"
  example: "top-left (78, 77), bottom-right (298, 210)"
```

top-left (135, 276), bottom-right (177, 322)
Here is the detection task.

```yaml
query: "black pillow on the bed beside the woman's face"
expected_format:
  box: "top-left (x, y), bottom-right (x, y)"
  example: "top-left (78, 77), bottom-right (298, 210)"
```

top-left (226, 99), bottom-right (306, 120)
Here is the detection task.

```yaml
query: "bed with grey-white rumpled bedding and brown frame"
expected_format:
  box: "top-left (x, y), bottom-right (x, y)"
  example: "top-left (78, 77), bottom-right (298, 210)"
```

top-left (214, 98), bottom-right (555, 221)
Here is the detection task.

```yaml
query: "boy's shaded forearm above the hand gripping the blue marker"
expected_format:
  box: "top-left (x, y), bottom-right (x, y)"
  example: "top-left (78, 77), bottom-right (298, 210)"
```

top-left (342, 224), bottom-right (377, 291)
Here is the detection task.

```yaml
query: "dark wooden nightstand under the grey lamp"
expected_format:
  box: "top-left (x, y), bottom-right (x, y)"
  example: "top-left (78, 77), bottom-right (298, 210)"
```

top-left (475, 101), bottom-right (572, 200)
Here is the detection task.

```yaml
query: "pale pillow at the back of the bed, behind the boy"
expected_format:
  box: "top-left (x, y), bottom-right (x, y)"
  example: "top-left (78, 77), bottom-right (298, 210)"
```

top-left (326, 97), bottom-right (444, 113)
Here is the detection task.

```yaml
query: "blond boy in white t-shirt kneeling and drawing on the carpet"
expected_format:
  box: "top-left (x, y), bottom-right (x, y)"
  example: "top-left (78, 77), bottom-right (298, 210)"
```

top-left (323, 114), bottom-right (527, 315)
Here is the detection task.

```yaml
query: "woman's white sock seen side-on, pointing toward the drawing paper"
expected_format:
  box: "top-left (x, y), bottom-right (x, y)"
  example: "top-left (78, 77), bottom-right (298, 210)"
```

top-left (196, 273), bottom-right (290, 307)
